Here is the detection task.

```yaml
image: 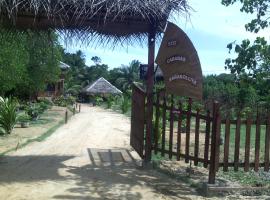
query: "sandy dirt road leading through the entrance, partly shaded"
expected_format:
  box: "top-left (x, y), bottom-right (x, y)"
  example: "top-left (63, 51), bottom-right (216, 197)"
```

top-left (0, 106), bottom-right (197, 200)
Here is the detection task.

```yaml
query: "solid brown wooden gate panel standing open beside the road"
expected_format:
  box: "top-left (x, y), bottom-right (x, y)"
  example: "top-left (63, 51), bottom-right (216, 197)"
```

top-left (130, 84), bottom-right (146, 158)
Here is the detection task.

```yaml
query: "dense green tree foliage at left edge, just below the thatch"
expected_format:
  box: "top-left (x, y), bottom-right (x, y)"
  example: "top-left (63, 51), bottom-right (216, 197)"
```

top-left (0, 30), bottom-right (61, 99)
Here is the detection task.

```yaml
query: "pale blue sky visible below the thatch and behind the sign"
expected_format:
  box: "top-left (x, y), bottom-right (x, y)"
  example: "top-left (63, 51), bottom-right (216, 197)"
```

top-left (61, 0), bottom-right (269, 75)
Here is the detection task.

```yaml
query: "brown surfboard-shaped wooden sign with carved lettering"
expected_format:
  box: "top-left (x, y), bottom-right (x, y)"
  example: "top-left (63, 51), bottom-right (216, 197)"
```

top-left (156, 22), bottom-right (202, 100)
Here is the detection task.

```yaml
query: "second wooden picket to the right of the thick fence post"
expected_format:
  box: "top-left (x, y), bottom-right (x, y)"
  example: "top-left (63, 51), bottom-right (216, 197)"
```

top-left (234, 115), bottom-right (241, 171)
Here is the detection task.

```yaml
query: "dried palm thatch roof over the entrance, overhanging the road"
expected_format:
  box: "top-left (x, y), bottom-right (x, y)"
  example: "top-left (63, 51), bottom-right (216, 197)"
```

top-left (0, 0), bottom-right (189, 44)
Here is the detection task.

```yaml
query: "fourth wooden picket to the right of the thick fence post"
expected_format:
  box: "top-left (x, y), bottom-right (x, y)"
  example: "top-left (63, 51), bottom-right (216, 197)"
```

top-left (254, 112), bottom-right (261, 172)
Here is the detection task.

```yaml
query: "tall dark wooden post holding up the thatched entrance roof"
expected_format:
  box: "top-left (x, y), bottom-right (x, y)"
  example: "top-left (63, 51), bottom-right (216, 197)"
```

top-left (144, 25), bottom-right (156, 163)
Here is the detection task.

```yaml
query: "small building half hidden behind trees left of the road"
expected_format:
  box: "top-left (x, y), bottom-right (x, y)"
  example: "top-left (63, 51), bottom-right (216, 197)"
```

top-left (38, 61), bottom-right (70, 98)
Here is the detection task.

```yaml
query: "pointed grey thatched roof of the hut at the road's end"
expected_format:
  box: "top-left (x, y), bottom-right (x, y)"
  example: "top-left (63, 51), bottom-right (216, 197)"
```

top-left (82, 77), bottom-right (122, 94)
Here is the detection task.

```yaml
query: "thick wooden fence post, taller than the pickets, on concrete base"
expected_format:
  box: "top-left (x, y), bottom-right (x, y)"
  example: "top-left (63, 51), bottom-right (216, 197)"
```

top-left (208, 102), bottom-right (221, 184)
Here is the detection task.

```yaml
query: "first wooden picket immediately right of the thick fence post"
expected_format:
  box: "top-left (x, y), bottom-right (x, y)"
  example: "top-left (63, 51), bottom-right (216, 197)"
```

top-left (223, 114), bottom-right (231, 172)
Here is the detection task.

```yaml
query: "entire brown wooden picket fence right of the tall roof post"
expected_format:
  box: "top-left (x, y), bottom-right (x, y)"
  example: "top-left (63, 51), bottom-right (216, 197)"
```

top-left (153, 94), bottom-right (270, 183)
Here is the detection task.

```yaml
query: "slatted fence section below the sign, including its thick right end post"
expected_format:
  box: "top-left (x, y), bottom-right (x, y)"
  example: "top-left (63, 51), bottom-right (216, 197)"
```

top-left (153, 94), bottom-right (220, 183)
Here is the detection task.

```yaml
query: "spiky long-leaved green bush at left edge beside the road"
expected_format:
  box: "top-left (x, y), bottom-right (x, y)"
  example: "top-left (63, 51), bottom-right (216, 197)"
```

top-left (0, 97), bottom-right (18, 134)
